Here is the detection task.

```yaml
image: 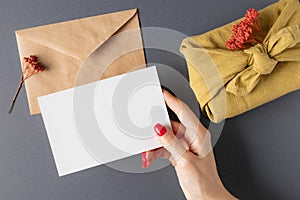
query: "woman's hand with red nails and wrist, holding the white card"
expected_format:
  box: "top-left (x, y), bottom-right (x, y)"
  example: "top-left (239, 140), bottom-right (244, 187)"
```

top-left (142, 90), bottom-right (235, 200)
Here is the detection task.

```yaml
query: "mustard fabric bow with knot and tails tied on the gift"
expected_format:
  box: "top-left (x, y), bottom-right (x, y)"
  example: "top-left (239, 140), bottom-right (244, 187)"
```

top-left (226, 25), bottom-right (300, 96)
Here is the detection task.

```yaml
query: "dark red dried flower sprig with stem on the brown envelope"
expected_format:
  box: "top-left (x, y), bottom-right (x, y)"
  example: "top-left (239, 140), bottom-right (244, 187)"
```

top-left (8, 55), bottom-right (46, 113)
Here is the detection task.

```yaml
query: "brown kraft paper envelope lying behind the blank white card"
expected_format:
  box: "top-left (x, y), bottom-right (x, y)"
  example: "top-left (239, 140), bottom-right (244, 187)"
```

top-left (16, 9), bottom-right (145, 114)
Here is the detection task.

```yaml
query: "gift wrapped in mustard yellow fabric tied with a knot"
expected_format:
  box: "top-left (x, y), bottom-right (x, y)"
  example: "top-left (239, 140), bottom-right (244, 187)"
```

top-left (180, 0), bottom-right (300, 122)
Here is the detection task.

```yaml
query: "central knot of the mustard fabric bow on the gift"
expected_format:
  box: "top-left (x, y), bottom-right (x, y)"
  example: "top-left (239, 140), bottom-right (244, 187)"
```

top-left (244, 44), bottom-right (278, 75)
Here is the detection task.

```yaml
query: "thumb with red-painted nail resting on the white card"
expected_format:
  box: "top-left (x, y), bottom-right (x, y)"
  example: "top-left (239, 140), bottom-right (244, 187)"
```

top-left (154, 123), bottom-right (186, 163)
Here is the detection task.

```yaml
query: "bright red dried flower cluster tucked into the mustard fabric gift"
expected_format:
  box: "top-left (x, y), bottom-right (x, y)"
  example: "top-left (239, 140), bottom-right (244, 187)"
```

top-left (226, 8), bottom-right (265, 50)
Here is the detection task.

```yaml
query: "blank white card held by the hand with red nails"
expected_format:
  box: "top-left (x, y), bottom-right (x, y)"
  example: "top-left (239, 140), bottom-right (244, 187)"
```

top-left (38, 67), bottom-right (170, 176)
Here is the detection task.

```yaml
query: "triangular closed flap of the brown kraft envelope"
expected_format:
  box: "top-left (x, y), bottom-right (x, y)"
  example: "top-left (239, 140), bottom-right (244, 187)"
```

top-left (16, 9), bottom-right (137, 60)
